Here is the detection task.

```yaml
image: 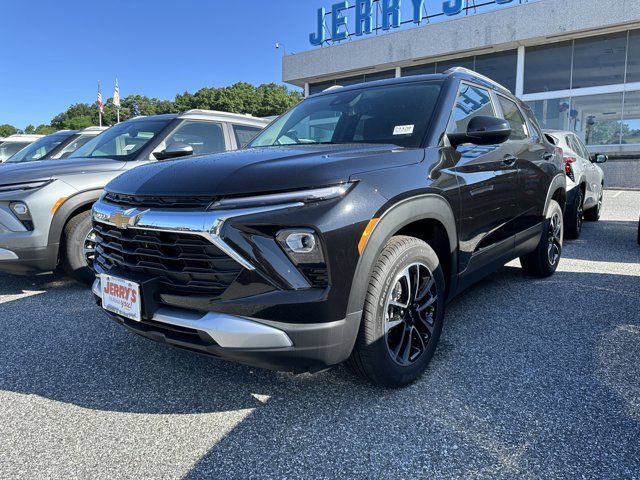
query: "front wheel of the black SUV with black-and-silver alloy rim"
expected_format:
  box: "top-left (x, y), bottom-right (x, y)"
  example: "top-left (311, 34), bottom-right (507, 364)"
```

top-left (347, 236), bottom-right (445, 388)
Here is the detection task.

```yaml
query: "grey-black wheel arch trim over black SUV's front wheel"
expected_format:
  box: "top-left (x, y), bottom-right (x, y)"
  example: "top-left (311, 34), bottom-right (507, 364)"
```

top-left (347, 194), bottom-right (458, 314)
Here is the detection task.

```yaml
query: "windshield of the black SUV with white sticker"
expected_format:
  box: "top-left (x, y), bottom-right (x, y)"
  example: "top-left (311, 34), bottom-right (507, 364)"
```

top-left (250, 81), bottom-right (441, 148)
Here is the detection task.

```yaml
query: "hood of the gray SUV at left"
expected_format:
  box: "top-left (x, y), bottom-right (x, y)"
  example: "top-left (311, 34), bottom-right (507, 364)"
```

top-left (0, 158), bottom-right (126, 185)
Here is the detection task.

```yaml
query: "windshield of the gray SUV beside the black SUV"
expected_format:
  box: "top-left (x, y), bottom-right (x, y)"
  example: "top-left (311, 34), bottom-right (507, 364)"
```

top-left (69, 119), bottom-right (171, 160)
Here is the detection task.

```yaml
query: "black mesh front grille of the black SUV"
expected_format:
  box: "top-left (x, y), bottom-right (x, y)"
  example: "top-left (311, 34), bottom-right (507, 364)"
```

top-left (94, 223), bottom-right (242, 297)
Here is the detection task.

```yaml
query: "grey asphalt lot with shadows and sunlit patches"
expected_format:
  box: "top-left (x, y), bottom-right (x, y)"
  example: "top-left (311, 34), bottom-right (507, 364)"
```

top-left (0, 191), bottom-right (640, 479)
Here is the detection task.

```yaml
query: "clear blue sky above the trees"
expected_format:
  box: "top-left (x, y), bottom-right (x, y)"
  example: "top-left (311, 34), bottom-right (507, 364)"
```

top-left (0, 0), bottom-right (312, 128)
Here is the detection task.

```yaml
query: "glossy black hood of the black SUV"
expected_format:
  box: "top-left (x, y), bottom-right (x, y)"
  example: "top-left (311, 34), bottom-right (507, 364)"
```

top-left (107, 144), bottom-right (424, 196)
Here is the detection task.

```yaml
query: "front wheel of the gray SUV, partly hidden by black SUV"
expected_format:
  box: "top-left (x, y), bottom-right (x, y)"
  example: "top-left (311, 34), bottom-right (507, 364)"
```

top-left (61, 211), bottom-right (95, 285)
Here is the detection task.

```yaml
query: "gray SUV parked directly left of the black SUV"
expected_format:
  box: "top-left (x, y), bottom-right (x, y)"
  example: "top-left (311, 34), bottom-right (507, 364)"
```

top-left (0, 110), bottom-right (269, 283)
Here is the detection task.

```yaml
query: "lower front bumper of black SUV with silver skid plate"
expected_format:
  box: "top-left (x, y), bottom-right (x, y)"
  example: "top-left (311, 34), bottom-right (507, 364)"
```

top-left (93, 278), bottom-right (360, 373)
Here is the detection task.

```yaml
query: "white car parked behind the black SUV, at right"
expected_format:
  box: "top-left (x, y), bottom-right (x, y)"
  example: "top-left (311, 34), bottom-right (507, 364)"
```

top-left (545, 130), bottom-right (608, 239)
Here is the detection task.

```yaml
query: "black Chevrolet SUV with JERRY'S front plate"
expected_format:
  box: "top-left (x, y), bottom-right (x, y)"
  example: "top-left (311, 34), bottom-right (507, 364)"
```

top-left (93, 68), bottom-right (566, 386)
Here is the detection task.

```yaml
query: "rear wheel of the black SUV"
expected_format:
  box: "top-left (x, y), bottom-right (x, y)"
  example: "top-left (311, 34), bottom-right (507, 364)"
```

top-left (520, 200), bottom-right (564, 278)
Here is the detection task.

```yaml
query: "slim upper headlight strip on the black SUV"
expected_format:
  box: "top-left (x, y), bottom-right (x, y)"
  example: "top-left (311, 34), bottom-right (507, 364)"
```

top-left (209, 183), bottom-right (354, 210)
